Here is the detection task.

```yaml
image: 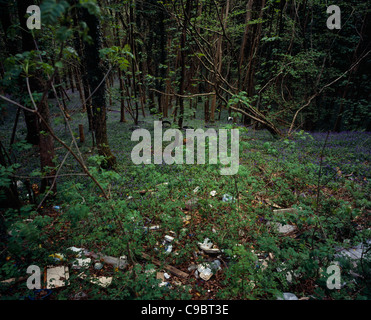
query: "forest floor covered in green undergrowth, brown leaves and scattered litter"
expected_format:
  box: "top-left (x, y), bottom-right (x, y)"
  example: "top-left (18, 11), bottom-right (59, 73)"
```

top-left (0, 85), bottom-right (371, 300)
